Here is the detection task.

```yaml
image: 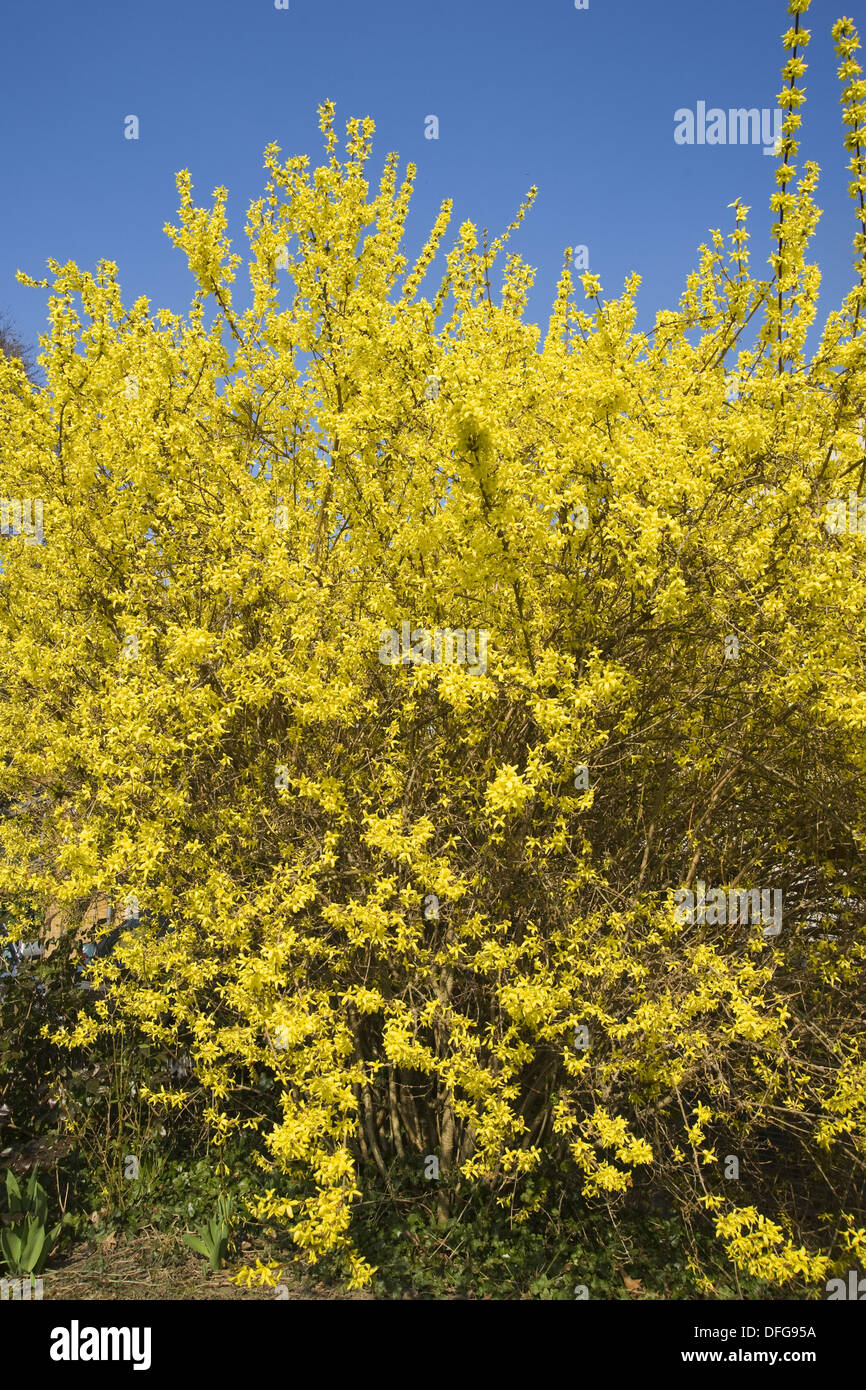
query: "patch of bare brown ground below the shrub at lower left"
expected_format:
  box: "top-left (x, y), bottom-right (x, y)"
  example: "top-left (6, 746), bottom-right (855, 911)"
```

top-left (42, 1230), bottom-right (374, 1302)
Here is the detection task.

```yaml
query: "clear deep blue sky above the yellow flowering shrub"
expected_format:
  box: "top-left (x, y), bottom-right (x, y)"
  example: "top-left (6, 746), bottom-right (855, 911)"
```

top-left (0, 0), bottom-right (866, 358)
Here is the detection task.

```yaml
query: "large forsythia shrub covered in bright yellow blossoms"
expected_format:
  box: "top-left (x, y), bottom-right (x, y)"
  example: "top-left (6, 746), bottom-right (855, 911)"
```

top-left (0, 0), bottom-right (866, 1284)
